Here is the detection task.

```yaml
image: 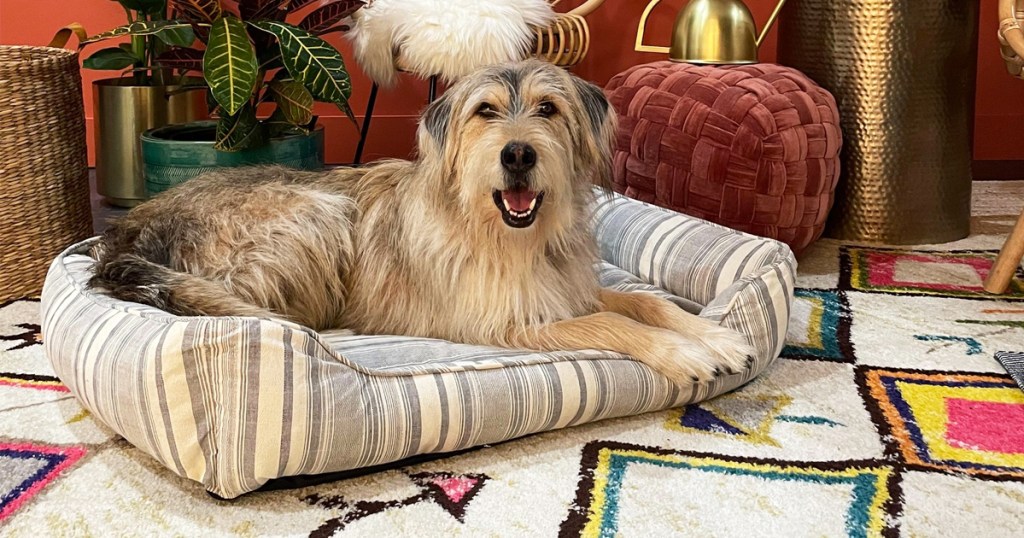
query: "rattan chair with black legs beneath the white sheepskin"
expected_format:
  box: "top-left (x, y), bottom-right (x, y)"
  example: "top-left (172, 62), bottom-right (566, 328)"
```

top-left (352, 0), bottom-right (604, 165)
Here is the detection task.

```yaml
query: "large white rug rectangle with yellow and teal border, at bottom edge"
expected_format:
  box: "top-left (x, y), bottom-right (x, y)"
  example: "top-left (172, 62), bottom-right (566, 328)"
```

top-left (561, 442), bottom-right (897, 536)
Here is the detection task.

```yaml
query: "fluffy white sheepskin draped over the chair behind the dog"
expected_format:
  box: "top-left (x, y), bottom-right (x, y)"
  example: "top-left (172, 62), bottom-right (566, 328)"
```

top-left (348, 0), bottom-right (555, 87)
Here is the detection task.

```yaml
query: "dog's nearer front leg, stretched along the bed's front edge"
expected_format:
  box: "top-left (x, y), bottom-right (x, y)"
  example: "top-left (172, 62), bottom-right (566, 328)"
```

top-left (509, 312), bottom-right (746, 384)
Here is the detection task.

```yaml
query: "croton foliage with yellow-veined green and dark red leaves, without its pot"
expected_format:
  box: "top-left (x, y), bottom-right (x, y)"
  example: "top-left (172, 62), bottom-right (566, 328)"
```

top-left (71, 0), bottom-right (366, 151)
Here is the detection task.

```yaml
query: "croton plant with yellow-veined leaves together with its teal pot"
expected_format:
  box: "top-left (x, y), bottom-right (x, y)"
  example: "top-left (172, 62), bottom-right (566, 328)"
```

top-left (73, 0), bottom-right (365, 196)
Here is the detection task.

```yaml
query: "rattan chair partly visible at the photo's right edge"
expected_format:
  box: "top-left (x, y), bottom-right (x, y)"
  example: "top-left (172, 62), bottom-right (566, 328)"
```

top-left (985, 0), bottom-right (1024, 293)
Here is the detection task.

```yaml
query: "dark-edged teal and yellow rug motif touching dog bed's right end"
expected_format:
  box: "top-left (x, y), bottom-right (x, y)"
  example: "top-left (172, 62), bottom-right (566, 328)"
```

top-left (782, 289), bottom-right (854, 363)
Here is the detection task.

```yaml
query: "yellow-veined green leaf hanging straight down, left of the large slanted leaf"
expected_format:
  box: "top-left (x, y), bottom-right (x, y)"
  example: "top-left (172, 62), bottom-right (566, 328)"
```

top-left (203, 16), bottom-right (258, 116)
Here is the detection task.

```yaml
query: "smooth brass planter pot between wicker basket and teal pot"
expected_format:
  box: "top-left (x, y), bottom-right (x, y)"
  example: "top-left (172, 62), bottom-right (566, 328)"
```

top-left (92, 78), bottom-right (207, 207)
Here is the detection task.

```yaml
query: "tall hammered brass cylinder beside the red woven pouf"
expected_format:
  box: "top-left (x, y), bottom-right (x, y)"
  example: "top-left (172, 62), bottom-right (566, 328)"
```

top-left (778, 0), bottom-right (978, 245)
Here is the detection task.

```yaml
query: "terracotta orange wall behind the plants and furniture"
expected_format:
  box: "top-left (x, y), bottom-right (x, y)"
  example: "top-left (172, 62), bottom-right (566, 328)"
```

top-left (0, 0), bottom-right (1024, 163)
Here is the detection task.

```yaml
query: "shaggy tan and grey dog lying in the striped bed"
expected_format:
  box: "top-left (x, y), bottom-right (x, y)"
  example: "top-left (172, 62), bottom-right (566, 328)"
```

top-left (90, 60), bottom-right (754, 384)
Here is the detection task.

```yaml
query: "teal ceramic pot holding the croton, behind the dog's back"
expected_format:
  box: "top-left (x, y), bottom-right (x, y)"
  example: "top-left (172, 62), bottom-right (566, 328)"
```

top-left (142, 121), bottom-right (324, 197)
